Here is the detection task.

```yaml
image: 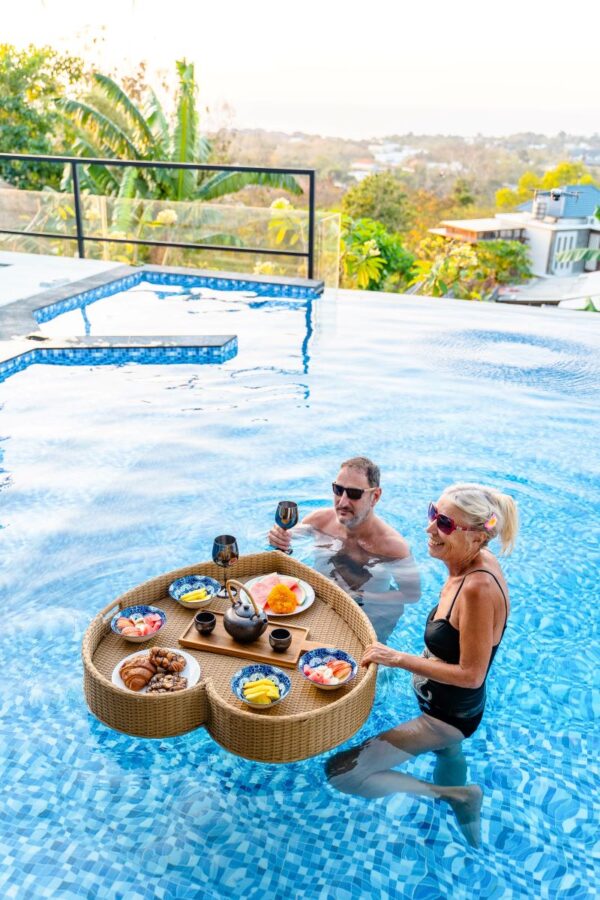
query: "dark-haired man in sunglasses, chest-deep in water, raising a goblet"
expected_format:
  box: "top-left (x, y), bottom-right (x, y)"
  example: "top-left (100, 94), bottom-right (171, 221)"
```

top-left (268, 456), bottom-right (421, 642)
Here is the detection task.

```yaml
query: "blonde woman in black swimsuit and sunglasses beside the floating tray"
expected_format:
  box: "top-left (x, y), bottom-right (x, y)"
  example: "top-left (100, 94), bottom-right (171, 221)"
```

top-left (327, 484), bottom-right (518, 845)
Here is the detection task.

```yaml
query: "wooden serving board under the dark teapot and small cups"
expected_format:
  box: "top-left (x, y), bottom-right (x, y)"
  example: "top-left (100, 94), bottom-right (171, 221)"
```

top-left (179, 610), bottom-right (323, 669)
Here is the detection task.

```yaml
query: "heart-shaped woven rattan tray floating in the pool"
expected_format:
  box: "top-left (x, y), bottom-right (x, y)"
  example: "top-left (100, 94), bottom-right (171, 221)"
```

top-left (82, 552), bottom-right (376, 762)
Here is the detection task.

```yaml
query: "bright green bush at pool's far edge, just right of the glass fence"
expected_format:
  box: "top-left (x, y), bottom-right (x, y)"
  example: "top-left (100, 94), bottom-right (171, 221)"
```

top-left (341, 217), bottom-right (414, 291)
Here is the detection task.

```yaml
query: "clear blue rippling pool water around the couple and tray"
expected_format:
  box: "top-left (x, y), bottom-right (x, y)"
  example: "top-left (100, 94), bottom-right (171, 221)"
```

top-left (0, 292), bottom-right (600, 900)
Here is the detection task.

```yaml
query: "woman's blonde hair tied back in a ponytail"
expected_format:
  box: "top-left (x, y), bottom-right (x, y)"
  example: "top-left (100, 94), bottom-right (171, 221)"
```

top-left (443, 484), bottom-right (519, 554)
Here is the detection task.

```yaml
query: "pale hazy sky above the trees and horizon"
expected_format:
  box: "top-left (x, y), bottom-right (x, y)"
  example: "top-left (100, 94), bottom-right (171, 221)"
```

top-left (0, 0), bottom-right (600, 138)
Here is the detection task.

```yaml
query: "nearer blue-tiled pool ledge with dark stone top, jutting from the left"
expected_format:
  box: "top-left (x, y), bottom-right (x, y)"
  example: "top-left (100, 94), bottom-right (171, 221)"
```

top-left (0, 334), bottom-right (238, 381)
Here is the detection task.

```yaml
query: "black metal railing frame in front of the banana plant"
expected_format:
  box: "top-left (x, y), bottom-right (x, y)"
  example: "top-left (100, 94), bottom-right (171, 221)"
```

top-left (0, 153), bottom-right (316, 278)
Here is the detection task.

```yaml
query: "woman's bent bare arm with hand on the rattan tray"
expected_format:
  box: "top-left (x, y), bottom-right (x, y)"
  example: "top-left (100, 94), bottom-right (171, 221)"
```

top-left (361, 579), bottom-right (494, 688)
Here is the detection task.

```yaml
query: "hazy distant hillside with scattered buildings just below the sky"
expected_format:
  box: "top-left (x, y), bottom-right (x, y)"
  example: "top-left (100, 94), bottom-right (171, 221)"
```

top-left (217, 129), bottom-right (600, 207)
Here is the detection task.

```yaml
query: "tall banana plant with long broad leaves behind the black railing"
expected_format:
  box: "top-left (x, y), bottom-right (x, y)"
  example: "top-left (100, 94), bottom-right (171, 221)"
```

top-left (58, 60), bottom-right (302, 200)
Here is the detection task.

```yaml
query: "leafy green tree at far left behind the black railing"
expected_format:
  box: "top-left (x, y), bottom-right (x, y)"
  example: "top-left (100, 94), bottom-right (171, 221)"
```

top-left (0, 44), bottom-right (83, 190)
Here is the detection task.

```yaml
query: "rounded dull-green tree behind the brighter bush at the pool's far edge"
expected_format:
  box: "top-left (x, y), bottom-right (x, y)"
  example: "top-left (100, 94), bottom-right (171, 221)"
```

top-left (342, 172), bottom-right (413, 231)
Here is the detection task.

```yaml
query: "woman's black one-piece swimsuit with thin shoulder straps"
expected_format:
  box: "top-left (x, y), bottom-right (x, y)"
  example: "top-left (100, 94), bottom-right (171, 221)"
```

top-left (413, 569), bottom-right (508, 737)
